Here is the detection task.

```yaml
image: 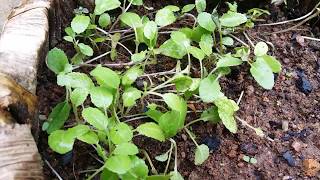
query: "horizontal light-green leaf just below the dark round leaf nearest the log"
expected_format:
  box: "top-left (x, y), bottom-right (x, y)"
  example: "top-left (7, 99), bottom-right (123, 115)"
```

top-left (57, 72), bottom-right (93, 89)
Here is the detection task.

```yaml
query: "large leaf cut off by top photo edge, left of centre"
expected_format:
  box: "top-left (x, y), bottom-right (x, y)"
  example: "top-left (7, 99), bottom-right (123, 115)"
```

top-left (94, 0), bottom-right (121, 15)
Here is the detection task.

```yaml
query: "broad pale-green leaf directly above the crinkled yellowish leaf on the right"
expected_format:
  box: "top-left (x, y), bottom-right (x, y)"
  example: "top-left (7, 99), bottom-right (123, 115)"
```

top-left (199, 75), bottom-right (224, 103)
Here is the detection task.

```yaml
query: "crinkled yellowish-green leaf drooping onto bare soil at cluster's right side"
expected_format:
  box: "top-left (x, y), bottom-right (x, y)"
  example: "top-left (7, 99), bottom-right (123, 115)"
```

top-left (214, 97), bottom-right (239, 133)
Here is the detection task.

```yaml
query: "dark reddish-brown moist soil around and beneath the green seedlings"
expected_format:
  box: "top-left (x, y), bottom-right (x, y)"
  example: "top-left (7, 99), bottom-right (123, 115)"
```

top-left (37, 1), bottom-right (320, 180)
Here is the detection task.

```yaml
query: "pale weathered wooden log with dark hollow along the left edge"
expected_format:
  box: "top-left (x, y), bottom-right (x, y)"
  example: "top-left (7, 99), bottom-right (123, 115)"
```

top-left (0, 0), bottom-right (50, 180)
